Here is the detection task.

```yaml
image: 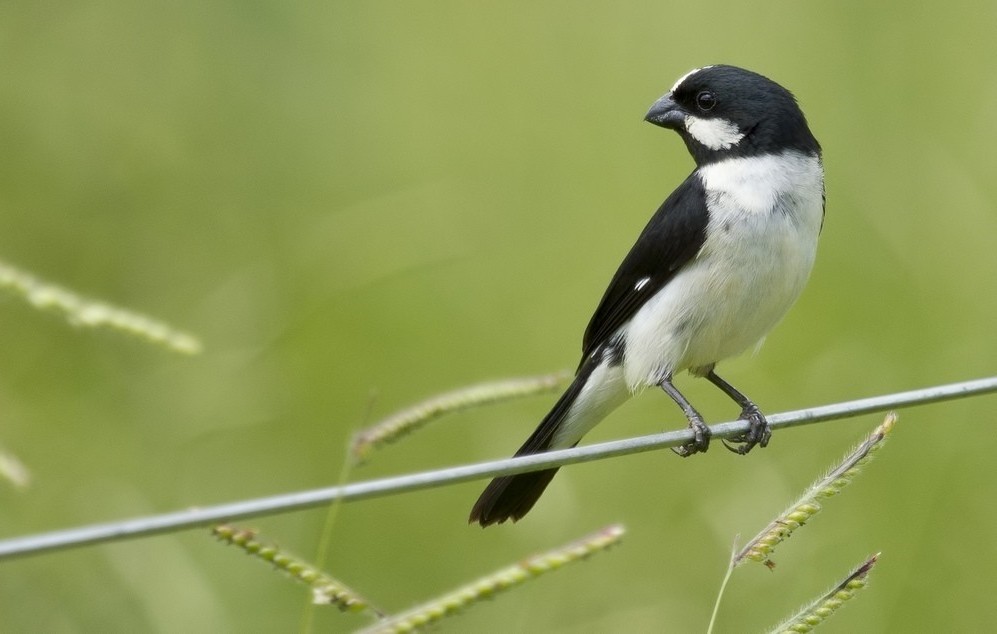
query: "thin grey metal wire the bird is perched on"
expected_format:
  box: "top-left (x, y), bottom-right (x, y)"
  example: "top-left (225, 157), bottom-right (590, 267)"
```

top-left (0, 377), bottom-right (997, 561)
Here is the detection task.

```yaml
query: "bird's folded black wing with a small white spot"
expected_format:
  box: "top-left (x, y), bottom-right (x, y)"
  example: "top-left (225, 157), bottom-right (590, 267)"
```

top-left (582, 172), bottom-right (709, 362)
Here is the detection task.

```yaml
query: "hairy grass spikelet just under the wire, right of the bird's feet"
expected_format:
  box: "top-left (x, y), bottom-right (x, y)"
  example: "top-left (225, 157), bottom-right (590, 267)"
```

top-left (733, 412), bottom-right (897, 568)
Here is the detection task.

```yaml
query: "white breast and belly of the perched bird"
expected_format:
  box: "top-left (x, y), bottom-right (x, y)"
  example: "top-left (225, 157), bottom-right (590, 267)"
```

top-left (624, 152), bottom-right (824, 390)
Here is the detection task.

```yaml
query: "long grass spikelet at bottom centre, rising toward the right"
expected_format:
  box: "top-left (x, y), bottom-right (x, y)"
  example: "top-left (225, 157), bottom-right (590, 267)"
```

top-left (363, 524), bottom-right (624, 634)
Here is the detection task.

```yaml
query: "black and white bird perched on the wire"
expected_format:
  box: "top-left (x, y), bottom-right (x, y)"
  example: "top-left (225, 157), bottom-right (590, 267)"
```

top-left (470, 65), bottom-right (824, 526)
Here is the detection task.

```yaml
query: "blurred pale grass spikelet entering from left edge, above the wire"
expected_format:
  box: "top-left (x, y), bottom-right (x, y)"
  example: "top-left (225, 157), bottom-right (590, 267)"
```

top-left (0, 262), bottom-right (201, 355)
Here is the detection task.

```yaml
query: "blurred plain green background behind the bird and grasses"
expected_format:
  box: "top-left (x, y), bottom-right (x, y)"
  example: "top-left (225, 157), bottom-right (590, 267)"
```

top-left (0, 0), bottom-right (997, 632)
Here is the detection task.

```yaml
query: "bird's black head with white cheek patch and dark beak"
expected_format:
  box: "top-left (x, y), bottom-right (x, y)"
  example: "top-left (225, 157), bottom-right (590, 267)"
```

top-left (644, 65), bottom-right (820, 165)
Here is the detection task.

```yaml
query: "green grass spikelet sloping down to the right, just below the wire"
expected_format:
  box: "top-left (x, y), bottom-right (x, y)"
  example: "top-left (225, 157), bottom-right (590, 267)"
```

top-left (211, 524), bottom-right (381, 615)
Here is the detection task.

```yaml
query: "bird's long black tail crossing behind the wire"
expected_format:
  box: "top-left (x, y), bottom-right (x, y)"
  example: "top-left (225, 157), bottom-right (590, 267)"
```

top-left (468, 362), bottom-right (597, 526)
